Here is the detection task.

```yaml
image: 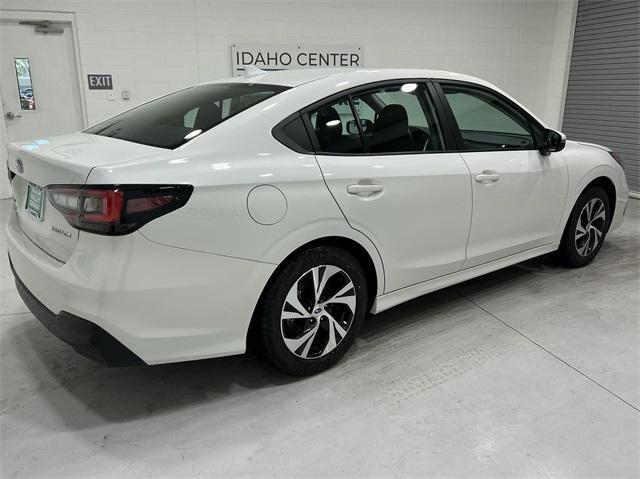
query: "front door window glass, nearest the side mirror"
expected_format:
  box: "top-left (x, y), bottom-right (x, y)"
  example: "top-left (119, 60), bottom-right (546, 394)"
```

top-left (442, 85), bottom-right (536, 151)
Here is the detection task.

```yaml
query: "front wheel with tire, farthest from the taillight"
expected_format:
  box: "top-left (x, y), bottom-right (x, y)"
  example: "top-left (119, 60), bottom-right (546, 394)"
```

top-left (558, 186), bottom-right (611, 268)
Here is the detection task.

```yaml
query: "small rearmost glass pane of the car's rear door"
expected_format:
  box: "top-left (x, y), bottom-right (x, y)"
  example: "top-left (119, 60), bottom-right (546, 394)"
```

top-left (309, 97), bottom-right (364, 153)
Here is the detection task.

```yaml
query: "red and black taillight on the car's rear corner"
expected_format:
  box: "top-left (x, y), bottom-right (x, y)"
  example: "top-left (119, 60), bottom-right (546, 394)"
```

top-left (47, 185), bottom-right (193, 235)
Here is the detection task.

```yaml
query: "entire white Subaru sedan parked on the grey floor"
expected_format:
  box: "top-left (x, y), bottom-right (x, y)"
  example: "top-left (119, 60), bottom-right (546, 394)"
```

top-left (7, 70), bottom-right (628, 375)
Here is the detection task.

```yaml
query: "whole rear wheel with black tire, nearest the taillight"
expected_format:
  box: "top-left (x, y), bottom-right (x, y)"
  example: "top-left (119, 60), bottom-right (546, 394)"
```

top-left (257, 247), bottom-right (367, 376)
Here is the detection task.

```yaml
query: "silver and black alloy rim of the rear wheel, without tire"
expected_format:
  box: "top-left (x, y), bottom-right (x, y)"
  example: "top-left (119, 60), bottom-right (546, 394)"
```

top-left (280, 265), bottom-right (356, 359)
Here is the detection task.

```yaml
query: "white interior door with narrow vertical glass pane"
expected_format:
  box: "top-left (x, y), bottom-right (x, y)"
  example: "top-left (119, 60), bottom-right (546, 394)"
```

top-left (0, 18), bottom-right (83, 197)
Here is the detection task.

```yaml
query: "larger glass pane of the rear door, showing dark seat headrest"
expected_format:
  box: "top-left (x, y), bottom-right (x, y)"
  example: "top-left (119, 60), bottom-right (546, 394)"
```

top-left (353, 82), bottom-right (443, 153)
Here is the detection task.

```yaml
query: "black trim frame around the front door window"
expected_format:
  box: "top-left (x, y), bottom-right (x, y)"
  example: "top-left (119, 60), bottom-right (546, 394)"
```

top-left (432, 78), bottom-right (546, 153)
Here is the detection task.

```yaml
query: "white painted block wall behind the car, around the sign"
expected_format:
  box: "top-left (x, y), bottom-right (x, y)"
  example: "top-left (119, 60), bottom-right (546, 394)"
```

top-left (2, 0), bottom-right (574, 126)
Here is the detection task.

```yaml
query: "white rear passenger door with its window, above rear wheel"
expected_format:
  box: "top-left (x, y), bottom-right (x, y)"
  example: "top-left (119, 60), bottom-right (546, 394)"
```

top-left (304, 81), bottom-right (471, 292)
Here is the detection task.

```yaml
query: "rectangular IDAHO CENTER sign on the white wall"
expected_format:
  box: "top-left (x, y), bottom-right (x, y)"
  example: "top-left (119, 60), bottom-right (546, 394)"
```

top-left (231, 43), bottom-right (363, 75)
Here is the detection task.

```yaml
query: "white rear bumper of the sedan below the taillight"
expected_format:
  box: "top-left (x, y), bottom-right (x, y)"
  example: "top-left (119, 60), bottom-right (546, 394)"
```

top-left (7, 204), bottom-right (276, 364)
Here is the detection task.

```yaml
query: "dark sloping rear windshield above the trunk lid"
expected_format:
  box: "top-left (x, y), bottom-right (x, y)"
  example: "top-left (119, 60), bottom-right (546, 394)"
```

top-left (85, 83), bottom-right (288, 149)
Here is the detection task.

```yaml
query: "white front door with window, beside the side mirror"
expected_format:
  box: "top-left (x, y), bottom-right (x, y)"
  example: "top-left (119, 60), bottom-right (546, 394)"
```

top-left (437, 82), bottom-right (568, 269)
